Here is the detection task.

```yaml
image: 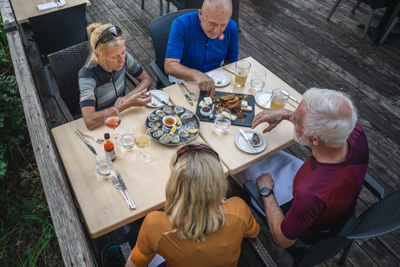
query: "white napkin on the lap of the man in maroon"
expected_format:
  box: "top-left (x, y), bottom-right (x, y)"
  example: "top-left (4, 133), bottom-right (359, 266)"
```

top-left (233, 151), bottom-right (304, 206)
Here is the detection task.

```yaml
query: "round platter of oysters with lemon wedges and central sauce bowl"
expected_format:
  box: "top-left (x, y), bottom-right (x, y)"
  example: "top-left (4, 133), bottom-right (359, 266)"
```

top-left (145, 106), bottom-right (200, 146)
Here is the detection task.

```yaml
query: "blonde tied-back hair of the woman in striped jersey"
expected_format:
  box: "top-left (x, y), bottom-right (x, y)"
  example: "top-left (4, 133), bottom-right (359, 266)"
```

top-left (85, 22), bottom-right (125, 68)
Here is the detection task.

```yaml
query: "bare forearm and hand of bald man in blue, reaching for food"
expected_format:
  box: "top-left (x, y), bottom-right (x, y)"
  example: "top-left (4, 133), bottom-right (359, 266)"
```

top-left (164, 58), bottom-right (215, 96)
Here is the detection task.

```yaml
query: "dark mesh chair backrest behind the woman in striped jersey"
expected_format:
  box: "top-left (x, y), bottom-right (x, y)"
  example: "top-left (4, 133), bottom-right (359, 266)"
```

top-left (48, 42), bottom-right (89, 115)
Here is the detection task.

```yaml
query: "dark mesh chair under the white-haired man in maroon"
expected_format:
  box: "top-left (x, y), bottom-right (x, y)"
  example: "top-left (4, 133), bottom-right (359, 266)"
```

top-left (243, 174), bottom-right (400, 266)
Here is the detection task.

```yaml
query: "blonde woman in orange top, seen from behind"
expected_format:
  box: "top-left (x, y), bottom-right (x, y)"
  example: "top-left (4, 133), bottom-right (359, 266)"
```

top-left (125, 144), bottom-right (259, 266)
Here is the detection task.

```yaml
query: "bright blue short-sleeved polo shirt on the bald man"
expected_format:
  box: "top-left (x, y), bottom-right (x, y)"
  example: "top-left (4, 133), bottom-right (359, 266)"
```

top-left (165, 11), bottom-right (239, 72)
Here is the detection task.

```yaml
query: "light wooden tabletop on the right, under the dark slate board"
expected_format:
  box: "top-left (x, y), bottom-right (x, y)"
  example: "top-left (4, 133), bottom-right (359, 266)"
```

top-left (164, 57), bottom-right (302, 174)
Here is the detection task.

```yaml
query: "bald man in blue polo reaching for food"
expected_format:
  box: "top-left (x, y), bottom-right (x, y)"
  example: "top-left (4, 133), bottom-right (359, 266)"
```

top-left (164, 0), bottom-right (239, 95)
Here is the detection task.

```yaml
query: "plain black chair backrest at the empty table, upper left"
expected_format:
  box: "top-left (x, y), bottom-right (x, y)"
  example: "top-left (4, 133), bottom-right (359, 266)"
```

top-left (29, 3), bottom-right (87, 58)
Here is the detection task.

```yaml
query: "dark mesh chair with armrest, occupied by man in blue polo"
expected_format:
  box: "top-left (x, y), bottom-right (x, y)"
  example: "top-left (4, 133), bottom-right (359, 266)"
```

top-left (149, 9), bottom-right (196, 88)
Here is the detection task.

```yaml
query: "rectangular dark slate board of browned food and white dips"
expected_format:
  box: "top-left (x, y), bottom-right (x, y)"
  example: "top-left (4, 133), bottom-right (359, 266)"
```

top-left (196, 91), bottom-right (255, 127)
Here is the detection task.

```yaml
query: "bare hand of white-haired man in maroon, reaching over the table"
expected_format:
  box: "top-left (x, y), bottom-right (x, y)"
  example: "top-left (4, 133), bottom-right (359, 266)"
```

top-left (251, 109), bottom-right (293, 133)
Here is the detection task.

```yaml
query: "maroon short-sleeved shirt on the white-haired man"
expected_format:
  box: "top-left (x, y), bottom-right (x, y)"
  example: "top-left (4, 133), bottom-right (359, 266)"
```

top-left (281, 123), bottom-right (369, 242)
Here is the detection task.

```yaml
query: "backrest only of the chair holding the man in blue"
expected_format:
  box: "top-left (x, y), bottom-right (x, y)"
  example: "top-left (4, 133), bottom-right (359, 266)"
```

top-left (149, 9), bottom-right (196, 74)
